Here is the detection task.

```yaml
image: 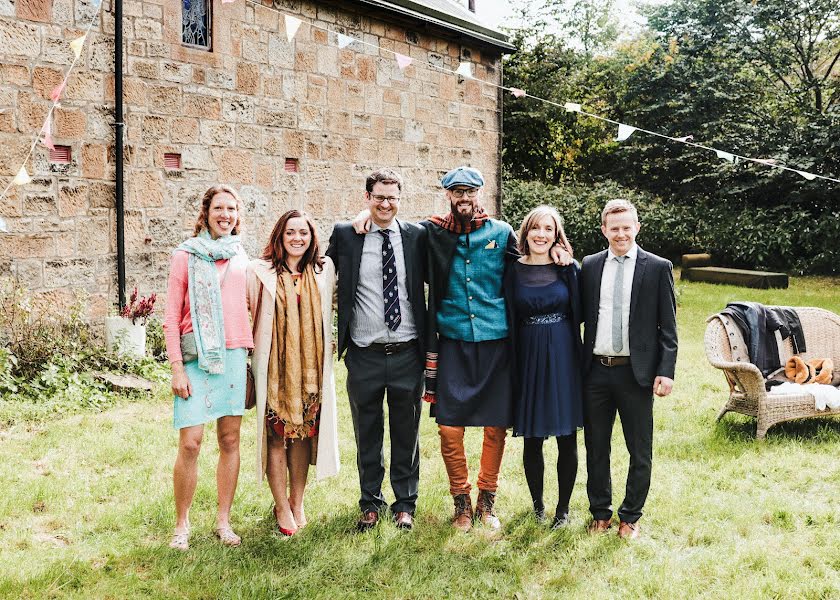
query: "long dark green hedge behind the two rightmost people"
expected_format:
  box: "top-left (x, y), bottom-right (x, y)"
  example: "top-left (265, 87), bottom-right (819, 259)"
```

top-left (503, 179), bottom-right (840, 274)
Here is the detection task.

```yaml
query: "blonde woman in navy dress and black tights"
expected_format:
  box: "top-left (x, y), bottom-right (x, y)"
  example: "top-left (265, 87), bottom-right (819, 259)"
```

top-left (506, 206), bottom-right (583, 527)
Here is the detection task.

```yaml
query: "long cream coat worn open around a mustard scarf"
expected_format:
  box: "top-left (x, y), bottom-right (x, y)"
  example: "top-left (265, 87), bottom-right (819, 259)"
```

top-left (247, 257), bottom-right (339, 481)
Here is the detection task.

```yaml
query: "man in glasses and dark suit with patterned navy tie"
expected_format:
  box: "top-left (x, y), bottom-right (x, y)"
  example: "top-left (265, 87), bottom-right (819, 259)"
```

top-left (326, 169), bottom-right (426, 531)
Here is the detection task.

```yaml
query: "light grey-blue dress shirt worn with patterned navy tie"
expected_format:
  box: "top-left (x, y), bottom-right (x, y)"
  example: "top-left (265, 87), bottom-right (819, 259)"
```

top-left (350, 219), bottom-right (417, 348)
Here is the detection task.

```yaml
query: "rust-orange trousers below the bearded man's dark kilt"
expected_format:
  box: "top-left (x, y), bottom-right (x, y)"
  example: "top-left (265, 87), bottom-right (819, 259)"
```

top-left (438, 425), bottom-right (507, 496)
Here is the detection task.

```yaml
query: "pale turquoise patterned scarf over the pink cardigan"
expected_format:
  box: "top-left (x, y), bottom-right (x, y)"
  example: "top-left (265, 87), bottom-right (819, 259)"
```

top-left (176, 229), bottom-right (245, 375)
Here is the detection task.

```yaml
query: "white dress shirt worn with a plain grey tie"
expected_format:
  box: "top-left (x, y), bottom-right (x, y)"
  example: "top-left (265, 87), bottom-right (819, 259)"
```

top-left (592, 244), bottom-right (639, 356)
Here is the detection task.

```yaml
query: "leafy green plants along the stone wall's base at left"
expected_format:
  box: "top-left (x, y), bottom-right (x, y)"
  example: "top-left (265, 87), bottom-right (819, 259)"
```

top-left (0, 280), bottom-right (167, 424)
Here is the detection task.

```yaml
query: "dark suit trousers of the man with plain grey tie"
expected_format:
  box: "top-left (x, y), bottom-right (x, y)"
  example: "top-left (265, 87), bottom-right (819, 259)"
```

top-left (583, 362), bottom-right (653, 523)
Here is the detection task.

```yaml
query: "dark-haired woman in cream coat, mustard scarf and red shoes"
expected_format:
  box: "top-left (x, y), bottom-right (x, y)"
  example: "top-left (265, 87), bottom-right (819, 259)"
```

top-left (247, 210), bottom-right (339, 536)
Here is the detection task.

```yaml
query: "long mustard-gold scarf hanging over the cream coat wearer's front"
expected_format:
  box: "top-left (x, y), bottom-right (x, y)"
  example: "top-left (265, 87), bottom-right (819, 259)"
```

top-left (267, 265), bottom-right (324, 438)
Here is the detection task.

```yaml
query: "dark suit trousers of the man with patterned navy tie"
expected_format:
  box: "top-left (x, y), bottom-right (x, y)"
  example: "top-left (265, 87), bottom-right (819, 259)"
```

top-left (344, 342), bottom-right (423, 514)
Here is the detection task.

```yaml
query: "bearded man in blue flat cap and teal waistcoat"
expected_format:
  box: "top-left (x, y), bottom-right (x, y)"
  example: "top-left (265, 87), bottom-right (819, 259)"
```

top-left (421, 167), bottom-right (519, 531)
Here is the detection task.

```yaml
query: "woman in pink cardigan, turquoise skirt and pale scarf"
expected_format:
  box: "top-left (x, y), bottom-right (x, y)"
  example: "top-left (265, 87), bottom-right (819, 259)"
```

top-left (163, 185), bottom-right (254, 550)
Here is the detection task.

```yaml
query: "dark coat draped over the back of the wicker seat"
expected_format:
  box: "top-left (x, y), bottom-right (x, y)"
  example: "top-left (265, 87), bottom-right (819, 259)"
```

top-left (720, 302), bottom-right (806, 377)
